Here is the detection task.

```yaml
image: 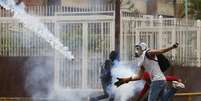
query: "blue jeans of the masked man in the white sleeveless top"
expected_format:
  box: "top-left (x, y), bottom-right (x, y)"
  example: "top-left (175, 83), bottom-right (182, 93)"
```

top-left (148, 80), bottom-right (166, 101)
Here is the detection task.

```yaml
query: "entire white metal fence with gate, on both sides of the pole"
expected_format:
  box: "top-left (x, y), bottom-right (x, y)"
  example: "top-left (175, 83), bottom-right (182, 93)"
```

top-left (0, 5), bottom-right (201, 89)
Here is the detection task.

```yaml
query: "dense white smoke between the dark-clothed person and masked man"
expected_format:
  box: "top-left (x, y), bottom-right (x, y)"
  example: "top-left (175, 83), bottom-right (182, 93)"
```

top-left (111, 63), bottom-right (144, 101)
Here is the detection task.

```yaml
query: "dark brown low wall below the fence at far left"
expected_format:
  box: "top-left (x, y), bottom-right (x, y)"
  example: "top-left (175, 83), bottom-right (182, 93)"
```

top-left (0, 56), bottom-right (54, 97)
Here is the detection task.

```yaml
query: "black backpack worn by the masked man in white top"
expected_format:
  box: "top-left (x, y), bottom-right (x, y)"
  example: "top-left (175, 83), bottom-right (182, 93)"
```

top-left (145, 52), bottom-right (171, 72)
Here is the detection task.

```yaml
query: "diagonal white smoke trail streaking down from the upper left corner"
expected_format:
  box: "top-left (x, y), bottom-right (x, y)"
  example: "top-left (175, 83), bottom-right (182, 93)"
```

top-left (0, 0), bottom-right (74, 59)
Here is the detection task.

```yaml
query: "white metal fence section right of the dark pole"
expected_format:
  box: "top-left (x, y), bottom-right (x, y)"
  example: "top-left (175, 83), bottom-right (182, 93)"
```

top-left (121, 16), bottom-right (201, 67)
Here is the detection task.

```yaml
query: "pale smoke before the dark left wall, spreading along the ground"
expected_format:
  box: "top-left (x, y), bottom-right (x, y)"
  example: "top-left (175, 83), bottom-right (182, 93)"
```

top-left (24, 57), bottom-right (93, 101)
